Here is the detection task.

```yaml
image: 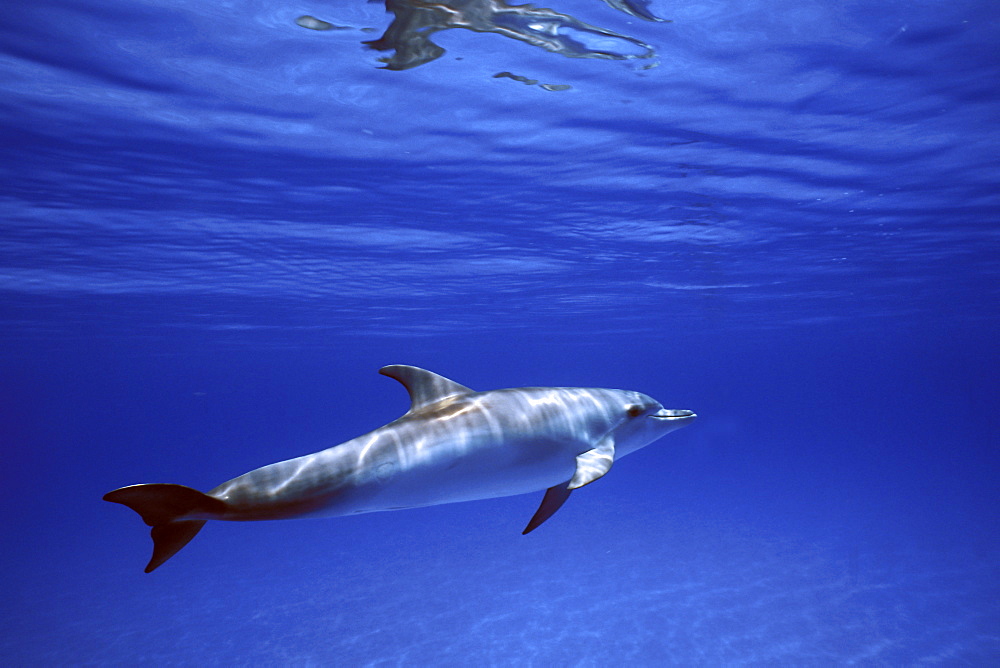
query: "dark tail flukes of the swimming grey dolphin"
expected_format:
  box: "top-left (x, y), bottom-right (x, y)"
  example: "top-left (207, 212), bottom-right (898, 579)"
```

top-left (104, 484), bottom-right (226, 573)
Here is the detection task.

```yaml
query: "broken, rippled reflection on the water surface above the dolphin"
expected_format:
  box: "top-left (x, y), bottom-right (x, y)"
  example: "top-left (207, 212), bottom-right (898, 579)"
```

top-left (296, 0), bottom-right (663, 70)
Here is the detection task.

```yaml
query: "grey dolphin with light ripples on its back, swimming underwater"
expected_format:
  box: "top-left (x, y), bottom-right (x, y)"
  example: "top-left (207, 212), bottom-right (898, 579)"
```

top-left (104, 364), bottom-right (696, 573)
